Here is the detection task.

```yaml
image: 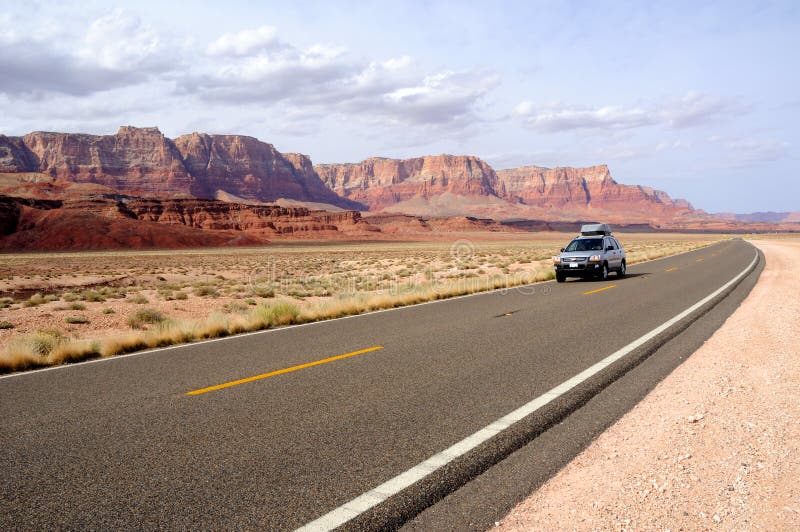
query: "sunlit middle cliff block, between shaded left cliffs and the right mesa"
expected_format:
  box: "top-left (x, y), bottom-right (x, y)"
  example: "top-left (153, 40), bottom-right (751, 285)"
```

top-left (315, 155), bottom-right (505, 211)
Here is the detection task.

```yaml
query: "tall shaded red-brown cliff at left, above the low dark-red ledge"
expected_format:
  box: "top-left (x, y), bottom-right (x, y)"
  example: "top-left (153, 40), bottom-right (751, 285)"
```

top-left (0, 126), bottom-right (362, 209)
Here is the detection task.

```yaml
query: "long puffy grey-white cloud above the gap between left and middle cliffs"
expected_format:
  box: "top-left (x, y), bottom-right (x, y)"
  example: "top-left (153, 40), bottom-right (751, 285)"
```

top-left (189, 27), bottom-right (497, 127)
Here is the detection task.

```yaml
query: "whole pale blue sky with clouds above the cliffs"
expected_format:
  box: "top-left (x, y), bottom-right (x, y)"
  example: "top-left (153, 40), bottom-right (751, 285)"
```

top-left (0, 0), bottom-right (800, 212)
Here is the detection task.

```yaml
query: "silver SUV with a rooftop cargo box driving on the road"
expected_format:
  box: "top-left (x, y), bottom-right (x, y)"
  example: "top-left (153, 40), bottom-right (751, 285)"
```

top-left (553, 224), bottom-right (627, 283)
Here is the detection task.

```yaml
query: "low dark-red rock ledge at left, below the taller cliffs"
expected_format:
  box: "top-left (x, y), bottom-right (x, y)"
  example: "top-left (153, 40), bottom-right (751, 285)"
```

top-left (0, 196), bottom-right (380, 250)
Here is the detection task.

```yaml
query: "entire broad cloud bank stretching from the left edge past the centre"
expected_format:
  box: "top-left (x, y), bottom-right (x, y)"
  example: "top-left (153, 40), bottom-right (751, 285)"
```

top-left (0, 18), bottom-right (499, 137)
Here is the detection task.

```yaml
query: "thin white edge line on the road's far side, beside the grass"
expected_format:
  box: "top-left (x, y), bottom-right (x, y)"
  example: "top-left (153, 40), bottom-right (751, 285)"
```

top-left (0, 240), bottom-right (736, 380)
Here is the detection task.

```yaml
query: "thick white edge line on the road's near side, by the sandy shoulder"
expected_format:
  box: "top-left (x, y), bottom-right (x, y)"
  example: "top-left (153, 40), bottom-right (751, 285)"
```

top-left (297, 250), bottom-right (758, 532)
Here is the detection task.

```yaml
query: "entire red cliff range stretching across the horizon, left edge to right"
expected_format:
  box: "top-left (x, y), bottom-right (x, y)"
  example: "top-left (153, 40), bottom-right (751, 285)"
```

top-left (0, 126), bottom-right (800, 228)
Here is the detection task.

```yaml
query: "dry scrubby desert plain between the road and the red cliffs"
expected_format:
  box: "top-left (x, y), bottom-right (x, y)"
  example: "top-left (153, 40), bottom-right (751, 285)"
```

top-left (0, 232), bottom-right (728, 372)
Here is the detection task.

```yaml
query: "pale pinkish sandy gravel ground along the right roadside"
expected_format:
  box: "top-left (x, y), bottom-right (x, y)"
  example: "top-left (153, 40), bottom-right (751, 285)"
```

top-left (499, 240), bottom-right (800, 530)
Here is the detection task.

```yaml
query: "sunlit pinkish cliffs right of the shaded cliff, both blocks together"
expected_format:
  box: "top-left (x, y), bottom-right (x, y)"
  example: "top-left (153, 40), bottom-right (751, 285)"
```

top-left (315, 155), bottom-right (698, 222)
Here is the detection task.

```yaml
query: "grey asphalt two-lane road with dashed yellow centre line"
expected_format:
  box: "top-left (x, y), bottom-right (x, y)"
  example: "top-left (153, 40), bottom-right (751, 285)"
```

top-left (0, 239), bottom-right (758, 530)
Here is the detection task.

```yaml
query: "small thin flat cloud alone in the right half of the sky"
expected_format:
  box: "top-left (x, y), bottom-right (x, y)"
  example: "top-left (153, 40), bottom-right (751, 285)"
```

top-left (512, 92), bottom-right (746, 133)
